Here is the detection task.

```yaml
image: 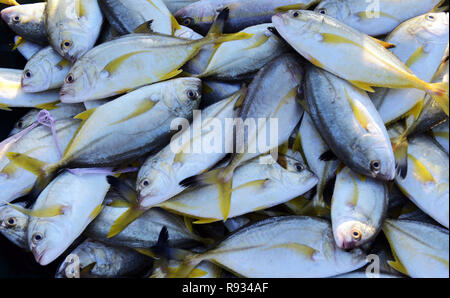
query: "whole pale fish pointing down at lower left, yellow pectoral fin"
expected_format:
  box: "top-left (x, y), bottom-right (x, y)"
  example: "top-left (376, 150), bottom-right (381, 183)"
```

top-left (27, 171), bottom-right (110, 266)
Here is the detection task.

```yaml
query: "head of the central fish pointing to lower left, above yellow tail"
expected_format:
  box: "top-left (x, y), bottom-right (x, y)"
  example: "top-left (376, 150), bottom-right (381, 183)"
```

top-left (136, 156), bottom-right (178, 208)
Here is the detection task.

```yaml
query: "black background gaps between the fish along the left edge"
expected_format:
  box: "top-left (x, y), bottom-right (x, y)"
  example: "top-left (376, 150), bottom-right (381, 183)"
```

top-left (0, 0), bottom-right (57, 278)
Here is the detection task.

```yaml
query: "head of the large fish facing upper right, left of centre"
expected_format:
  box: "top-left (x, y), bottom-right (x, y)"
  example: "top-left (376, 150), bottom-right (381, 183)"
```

top-left (159, 78), bottom-right (202, 117)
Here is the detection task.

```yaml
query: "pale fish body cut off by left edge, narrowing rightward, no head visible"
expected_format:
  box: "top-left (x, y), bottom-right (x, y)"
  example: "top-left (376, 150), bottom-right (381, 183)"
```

top-left (0, 68), bottom-right (59, 111)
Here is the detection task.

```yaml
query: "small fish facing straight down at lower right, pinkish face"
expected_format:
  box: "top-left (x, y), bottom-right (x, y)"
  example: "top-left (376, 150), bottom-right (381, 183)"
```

top-left (331, 167), bottom-right (389, 249)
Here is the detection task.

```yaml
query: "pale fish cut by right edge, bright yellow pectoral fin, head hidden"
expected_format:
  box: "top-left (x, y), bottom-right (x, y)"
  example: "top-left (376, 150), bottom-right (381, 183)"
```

top-left (395, 135), bottom-right (449, 228)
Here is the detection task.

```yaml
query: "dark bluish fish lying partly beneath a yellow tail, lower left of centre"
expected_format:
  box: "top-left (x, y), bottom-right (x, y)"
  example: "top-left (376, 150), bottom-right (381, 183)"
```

top-left (85, 206), bottom-right (205, 249)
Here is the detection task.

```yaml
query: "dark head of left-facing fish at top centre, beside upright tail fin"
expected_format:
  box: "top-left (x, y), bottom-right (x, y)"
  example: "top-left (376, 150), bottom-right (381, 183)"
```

top-left (174, 1), bottom-right (219, 33)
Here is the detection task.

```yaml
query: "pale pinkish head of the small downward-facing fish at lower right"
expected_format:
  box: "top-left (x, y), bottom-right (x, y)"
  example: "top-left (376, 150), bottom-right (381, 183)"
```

top-left (333, 219), bottom-right (377, 249)
